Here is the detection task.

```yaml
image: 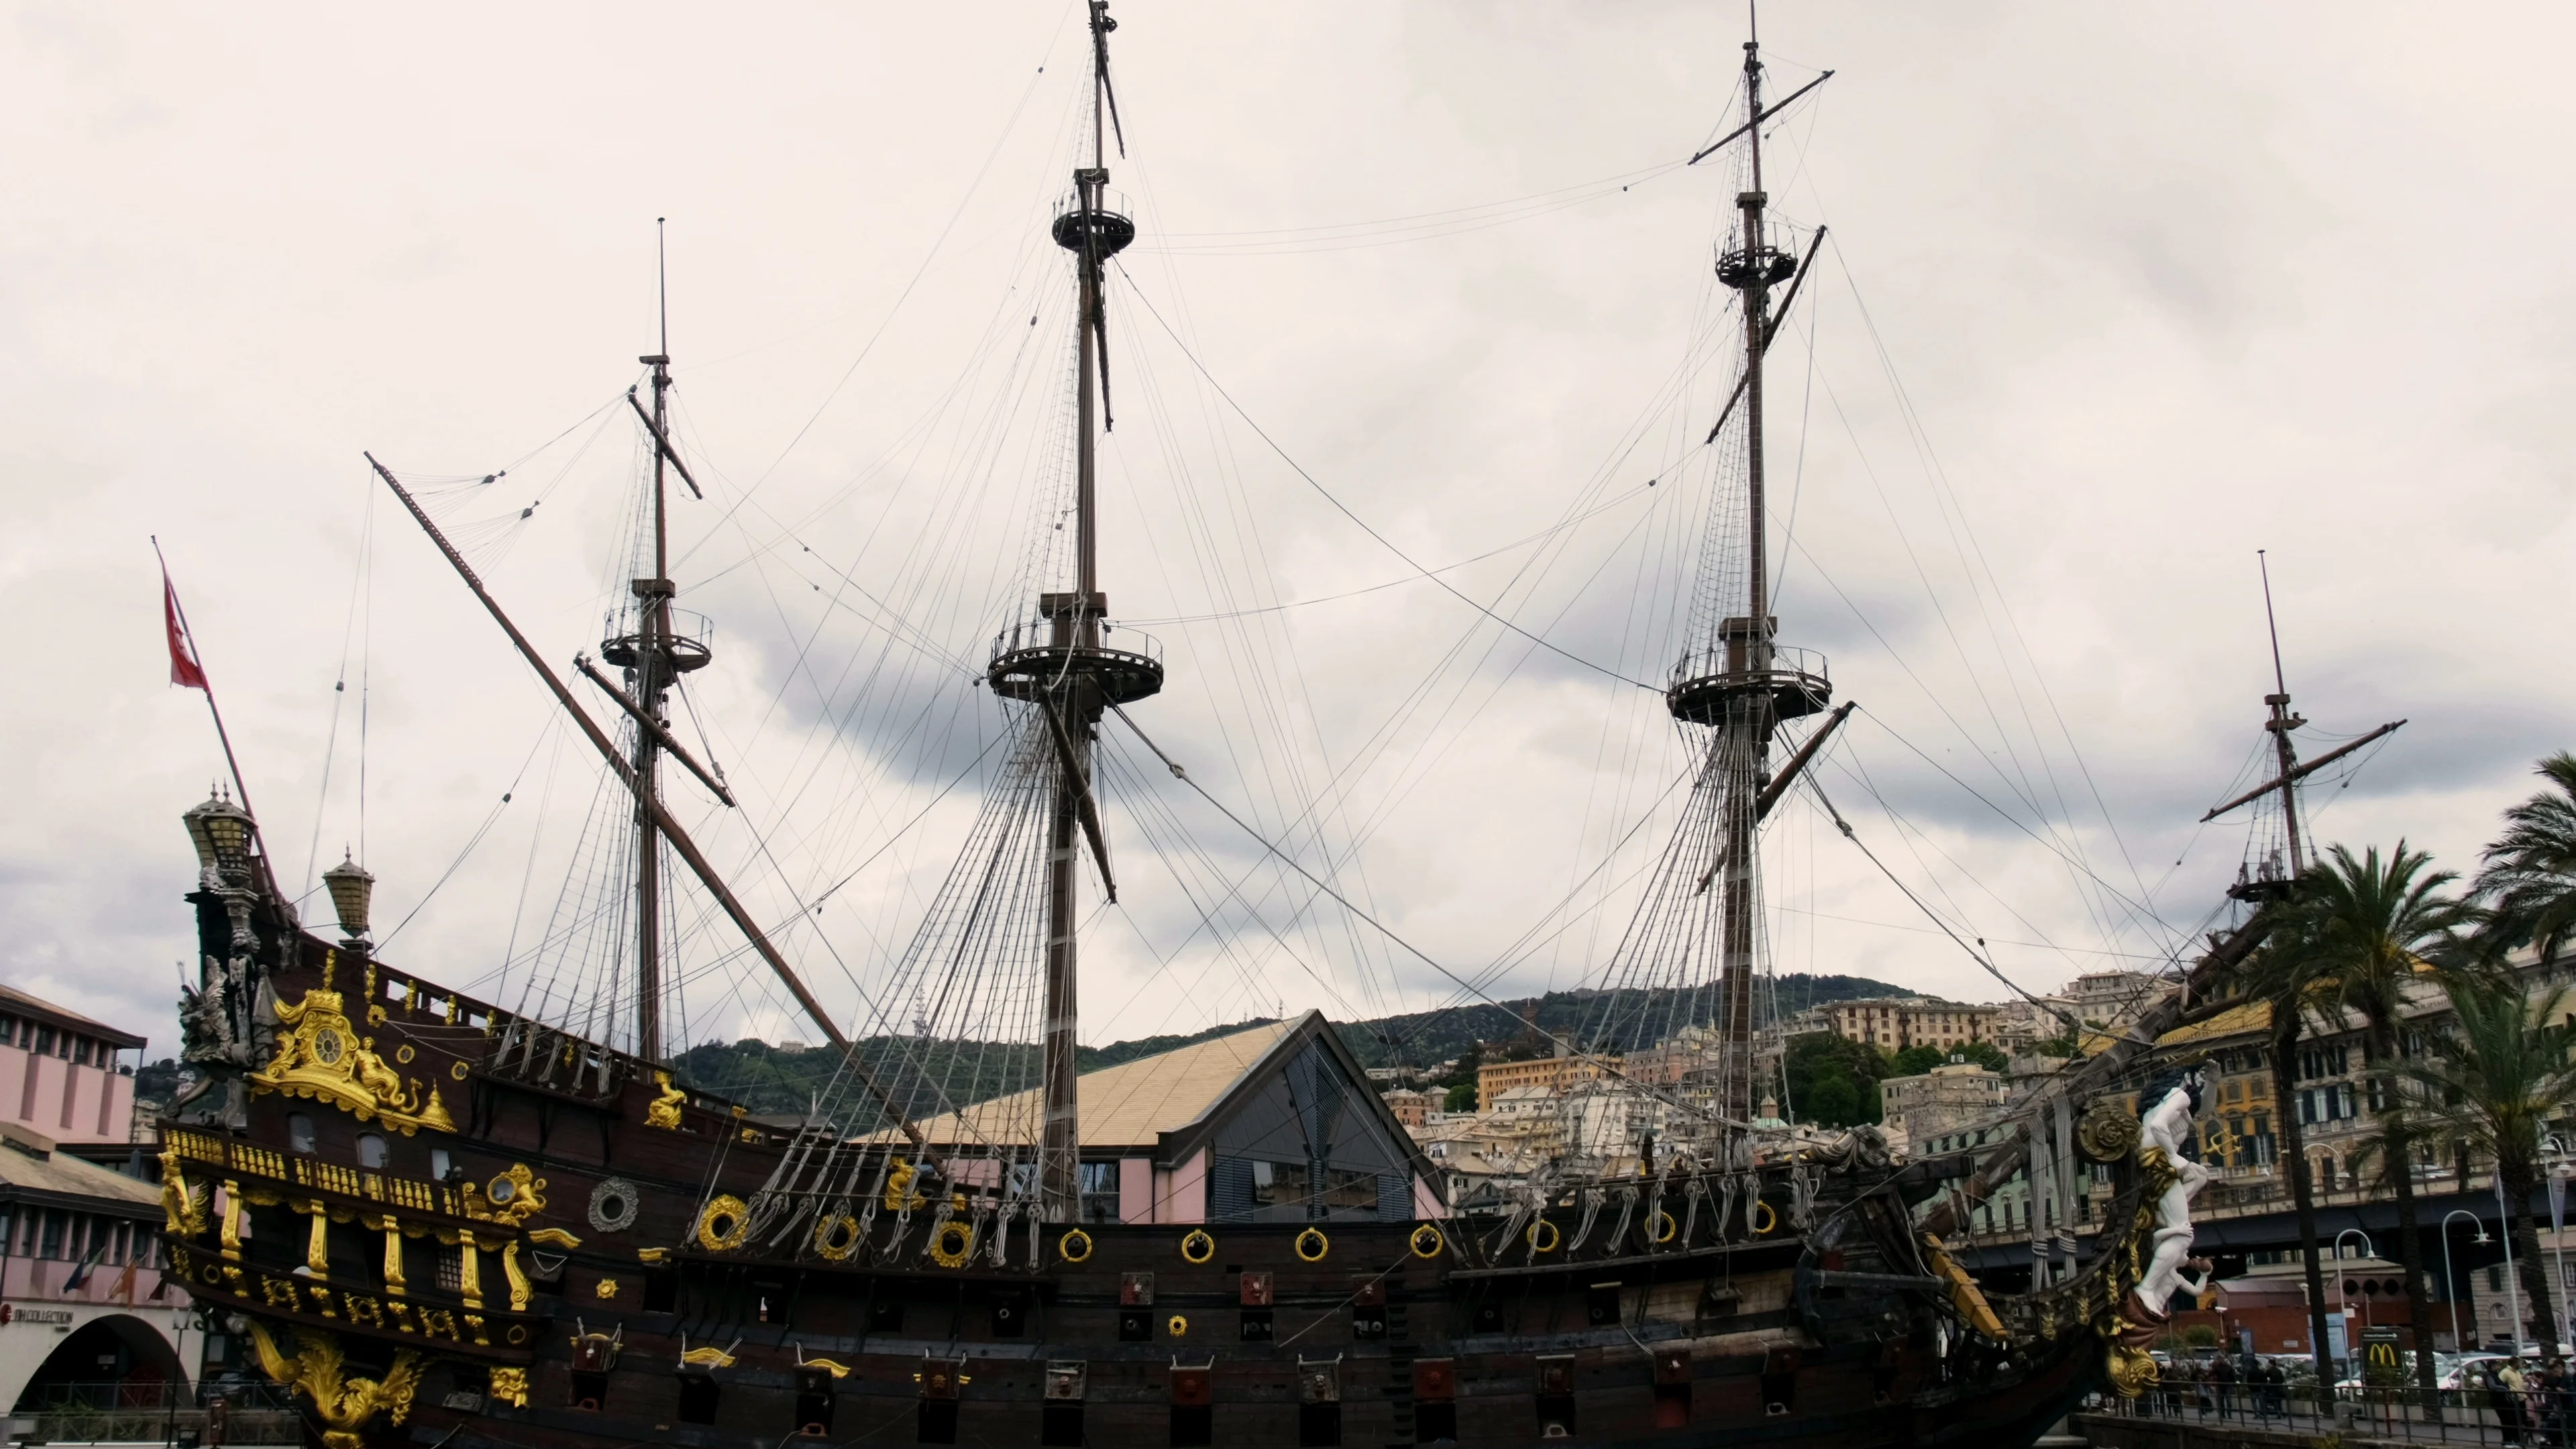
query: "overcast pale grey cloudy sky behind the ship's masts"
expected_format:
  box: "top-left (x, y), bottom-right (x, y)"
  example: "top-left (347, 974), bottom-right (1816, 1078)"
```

top-left (0, 0), bottom-right (2576, 1055)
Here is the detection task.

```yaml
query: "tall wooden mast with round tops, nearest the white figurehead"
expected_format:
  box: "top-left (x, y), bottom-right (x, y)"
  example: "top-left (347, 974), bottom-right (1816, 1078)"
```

top-left (1664, 14), bottom-right (1831, 1122)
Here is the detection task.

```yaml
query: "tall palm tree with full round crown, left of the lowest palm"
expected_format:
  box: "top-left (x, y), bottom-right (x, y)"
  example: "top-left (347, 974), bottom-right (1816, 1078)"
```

top-left (2285, 841), bottom-right (2473, 1400)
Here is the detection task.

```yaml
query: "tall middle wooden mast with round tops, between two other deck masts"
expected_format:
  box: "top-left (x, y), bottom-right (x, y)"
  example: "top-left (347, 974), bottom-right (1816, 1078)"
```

top-left (987, 0), bottom-right (1162, 1222)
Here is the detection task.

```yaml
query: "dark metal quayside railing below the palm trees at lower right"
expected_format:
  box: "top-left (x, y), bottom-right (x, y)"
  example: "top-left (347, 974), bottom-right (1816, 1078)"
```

top-left (2074, 1354), bottom-right (2576, 1446)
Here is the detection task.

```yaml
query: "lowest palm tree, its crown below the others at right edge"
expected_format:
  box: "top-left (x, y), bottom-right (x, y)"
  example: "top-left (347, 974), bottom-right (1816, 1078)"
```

top-left (2388, 972), bottom-right (2576, 1343)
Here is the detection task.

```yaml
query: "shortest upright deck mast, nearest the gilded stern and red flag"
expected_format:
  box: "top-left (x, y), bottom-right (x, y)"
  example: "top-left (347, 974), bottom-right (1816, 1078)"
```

top-left (600, 217), bottom-right (711, 1062)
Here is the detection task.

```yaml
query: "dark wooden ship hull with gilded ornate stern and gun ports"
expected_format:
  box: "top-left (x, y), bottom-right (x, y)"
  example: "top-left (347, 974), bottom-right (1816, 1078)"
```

top-left (162, 890), bottom-right (2135, 1449)
